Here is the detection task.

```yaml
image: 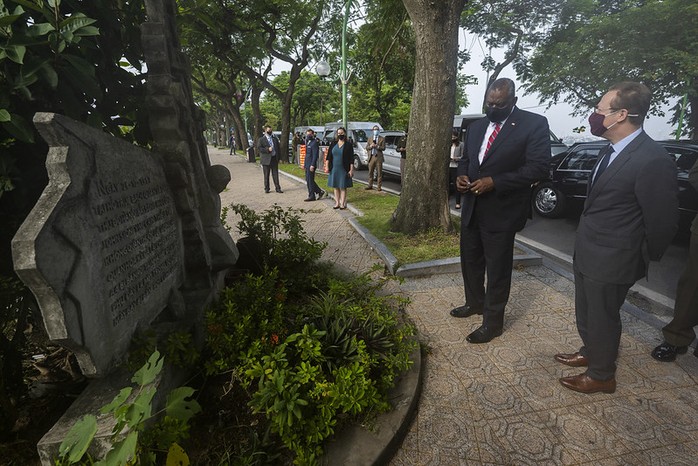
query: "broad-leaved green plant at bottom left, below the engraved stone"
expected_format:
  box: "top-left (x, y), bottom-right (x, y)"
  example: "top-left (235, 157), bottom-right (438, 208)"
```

top-left (57, 351), bottom-right (201, 465)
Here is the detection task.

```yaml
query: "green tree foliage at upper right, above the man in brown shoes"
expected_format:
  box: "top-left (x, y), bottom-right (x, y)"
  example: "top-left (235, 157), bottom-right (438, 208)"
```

top-left (521, 0), bottom-right (698, 135)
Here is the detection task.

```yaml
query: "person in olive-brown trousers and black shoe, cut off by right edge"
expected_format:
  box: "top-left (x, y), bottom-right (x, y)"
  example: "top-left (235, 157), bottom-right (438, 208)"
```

top-left (652, 161), bottom-right (698, 362)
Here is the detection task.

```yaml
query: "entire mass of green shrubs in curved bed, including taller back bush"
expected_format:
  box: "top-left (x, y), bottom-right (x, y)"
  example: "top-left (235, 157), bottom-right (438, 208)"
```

top-left (204, 205), bottom-right (417, 464)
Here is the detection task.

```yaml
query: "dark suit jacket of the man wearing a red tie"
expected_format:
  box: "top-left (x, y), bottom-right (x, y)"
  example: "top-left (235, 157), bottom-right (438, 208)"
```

top-left (456, 107), bottom-right (550, 232)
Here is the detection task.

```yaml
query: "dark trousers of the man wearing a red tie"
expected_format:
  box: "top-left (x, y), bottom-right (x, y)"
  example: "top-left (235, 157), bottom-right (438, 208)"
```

top-left (460, 215), bottom-right (516, 330)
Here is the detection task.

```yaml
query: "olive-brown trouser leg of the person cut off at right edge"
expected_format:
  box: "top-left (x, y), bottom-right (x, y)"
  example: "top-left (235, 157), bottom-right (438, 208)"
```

top-left (662, 232), bottom-right (698, 346)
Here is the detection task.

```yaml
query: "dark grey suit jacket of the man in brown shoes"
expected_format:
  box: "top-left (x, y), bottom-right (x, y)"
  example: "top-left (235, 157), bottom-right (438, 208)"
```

top-left (574, 132), bottom-right (679, 284)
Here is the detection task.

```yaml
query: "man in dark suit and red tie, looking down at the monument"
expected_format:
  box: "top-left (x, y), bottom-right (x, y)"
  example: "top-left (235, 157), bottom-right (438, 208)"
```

top-left (451, 78), bottom-right (550, 343)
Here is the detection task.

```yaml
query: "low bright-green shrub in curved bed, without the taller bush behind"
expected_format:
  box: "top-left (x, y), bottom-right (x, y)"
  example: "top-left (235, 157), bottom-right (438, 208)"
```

top-left (207, 271), bottom-right (416, 464)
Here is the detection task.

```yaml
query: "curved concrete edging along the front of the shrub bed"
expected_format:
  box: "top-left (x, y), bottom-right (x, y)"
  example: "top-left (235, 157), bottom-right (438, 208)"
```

top-left (320, 348), bottom-right (422, 466)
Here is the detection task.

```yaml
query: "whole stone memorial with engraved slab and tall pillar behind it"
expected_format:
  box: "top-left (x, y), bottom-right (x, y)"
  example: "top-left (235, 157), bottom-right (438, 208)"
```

top-left (12, 0), bottom-right (238, 458)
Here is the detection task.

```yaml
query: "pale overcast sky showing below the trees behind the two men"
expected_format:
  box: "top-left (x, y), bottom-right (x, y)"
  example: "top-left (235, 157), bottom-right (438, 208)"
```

top-left (459, 29), bottom-right (674, 142)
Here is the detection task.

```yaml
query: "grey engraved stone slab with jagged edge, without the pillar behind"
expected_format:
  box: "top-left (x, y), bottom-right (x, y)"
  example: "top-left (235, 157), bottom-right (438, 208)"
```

top-left (12, 113), bottom-right (183, 377)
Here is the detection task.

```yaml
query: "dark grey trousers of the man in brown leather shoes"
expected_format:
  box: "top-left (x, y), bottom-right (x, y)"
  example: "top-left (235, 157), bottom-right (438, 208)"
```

top-left (574, 267), bottom-right (632, 380)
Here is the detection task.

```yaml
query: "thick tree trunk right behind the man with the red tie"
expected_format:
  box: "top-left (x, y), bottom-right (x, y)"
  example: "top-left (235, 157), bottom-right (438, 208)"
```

top-left (392, 0), bottom-right (466, 233)
